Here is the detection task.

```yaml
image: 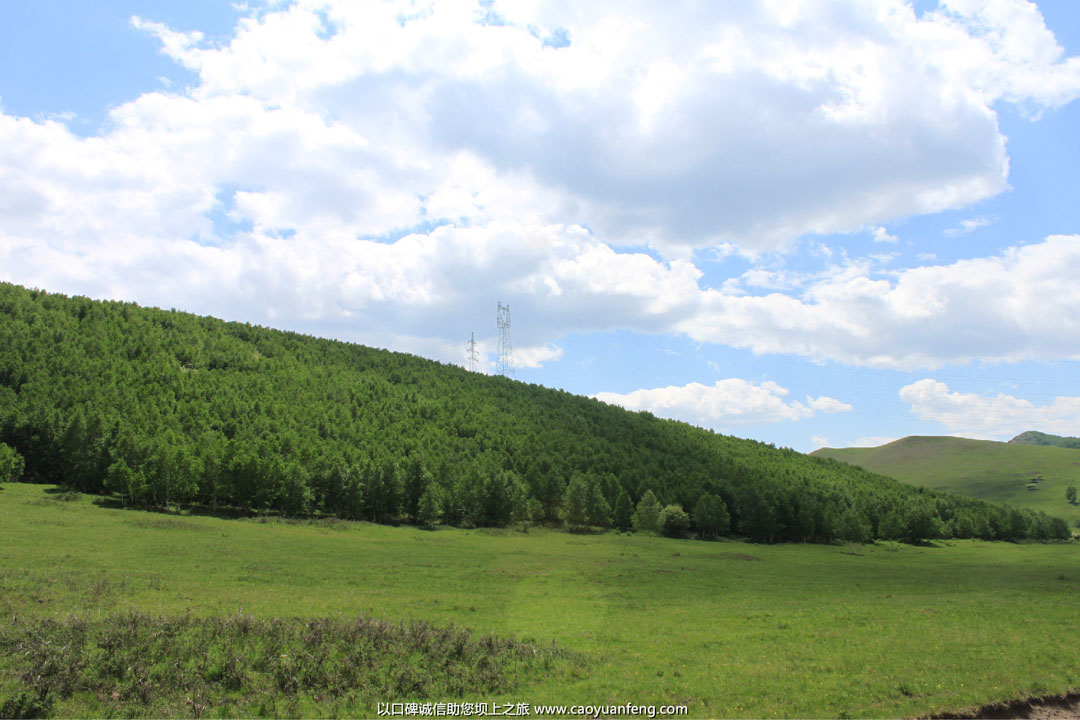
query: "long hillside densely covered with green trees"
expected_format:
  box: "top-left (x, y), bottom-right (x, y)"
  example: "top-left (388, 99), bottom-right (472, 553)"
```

top-left (0, 284), bottom-right (1068, 542)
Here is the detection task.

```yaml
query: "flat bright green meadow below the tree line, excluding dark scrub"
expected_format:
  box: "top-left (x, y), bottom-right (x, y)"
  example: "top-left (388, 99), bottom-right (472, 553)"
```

top-left (0, 484), bottom-right (1080, 718)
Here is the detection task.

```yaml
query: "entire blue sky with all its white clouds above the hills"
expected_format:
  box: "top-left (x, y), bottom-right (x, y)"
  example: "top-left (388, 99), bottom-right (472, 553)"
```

top-left (0, 0), bottom-right (1080, 451)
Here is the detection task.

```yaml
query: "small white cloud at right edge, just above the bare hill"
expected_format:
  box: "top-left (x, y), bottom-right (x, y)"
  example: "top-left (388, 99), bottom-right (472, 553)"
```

top-left (900, 378), bottom-right (1080, 440)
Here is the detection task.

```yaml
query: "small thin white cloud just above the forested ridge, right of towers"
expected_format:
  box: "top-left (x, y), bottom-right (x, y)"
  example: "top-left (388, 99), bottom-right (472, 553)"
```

top-left (594, 378), bottom-right (852, 431)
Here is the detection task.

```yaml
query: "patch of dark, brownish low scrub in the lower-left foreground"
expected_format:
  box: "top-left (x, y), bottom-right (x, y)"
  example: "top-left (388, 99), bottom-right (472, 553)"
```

top-left (0, 613), bottom-right (582, 718)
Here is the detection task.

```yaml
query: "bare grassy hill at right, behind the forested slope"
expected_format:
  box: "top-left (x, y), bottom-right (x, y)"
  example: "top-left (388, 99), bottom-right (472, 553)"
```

top-left (811, 437), bottom-right (1080, 525)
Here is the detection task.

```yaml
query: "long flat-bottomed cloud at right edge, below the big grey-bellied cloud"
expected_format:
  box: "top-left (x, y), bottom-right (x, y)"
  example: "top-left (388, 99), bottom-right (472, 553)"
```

top-left (679, 235), bottom-right (1080, 369)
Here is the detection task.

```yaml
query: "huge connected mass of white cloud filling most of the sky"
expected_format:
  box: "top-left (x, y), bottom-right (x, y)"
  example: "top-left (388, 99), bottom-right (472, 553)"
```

top-left (0, 0), bottom-right (1080, 371)
